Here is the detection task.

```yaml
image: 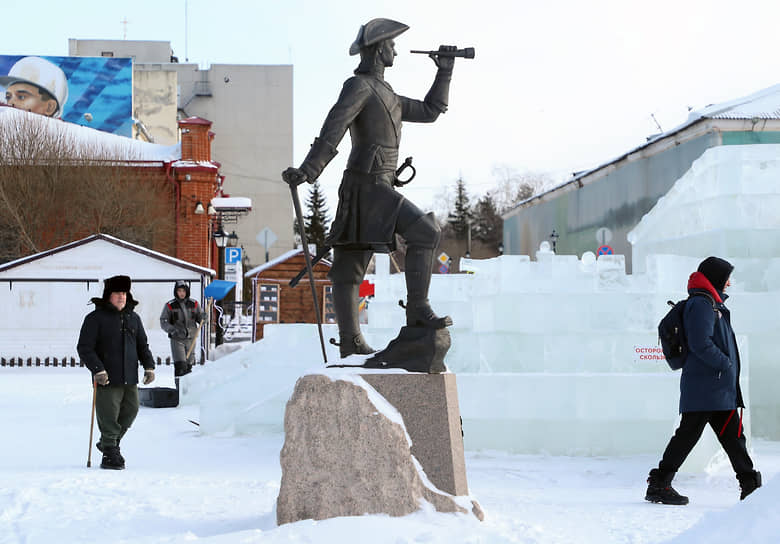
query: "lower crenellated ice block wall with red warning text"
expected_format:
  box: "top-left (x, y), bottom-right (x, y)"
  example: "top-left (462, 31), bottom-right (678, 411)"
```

top-left (368, 251), bottom-right (748, 468)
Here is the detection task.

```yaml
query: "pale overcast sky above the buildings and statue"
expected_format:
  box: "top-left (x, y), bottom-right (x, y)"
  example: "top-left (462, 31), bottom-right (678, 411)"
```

top-left (0, 0), bottom-right (780, 209)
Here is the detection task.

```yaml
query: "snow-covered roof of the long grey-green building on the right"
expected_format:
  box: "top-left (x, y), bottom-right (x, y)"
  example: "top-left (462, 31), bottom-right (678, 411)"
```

top-left (504, 84), bottom-right (780, 217)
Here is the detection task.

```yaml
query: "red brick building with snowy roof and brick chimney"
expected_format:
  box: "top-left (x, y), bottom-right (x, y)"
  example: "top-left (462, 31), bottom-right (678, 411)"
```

top-left (0, 106), bottom-right (232, 274)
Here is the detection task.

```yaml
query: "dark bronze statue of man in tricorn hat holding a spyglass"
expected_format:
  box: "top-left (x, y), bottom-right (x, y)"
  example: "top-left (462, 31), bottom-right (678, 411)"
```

top-left (282, 19), bottom-right (455, 357)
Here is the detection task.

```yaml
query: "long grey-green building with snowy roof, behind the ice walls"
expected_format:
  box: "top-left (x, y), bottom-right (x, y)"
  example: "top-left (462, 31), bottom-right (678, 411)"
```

top-left (503, 85), bottom-right (780, 271)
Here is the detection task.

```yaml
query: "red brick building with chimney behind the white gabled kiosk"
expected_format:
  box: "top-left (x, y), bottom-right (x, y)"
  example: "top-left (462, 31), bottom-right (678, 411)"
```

top-left (0, 107), bottom-right (224, 269)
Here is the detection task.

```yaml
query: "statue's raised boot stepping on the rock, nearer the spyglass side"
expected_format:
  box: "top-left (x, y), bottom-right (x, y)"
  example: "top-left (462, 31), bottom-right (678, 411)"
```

top-left (405, 246), bottom-right (452, 329)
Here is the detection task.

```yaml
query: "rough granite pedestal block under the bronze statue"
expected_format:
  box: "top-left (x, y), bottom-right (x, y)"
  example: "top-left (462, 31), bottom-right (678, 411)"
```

top-left (276, 373), bottom-right (484, 524)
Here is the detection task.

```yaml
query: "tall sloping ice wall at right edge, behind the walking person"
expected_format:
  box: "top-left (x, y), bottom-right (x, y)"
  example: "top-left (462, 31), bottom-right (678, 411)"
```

top-left (628, 144), bottom-right (780, 440)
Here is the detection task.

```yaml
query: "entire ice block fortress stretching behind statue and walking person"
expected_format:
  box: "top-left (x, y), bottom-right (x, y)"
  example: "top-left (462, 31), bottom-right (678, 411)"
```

top-left (183, 145), bottom-right (780, 467)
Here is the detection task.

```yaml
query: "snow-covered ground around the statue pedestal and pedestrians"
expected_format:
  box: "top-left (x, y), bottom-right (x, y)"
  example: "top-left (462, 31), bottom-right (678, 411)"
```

top-left (0, 361), bottom-right (780, 544)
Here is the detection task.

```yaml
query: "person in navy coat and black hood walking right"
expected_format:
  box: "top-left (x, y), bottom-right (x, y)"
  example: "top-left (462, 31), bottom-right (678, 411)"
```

top-left (645, 257), bottom-right (761, 504)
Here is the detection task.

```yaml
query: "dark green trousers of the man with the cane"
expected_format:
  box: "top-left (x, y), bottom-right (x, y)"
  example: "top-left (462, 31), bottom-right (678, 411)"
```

top-left (95, 385), bottom-right (138, 447)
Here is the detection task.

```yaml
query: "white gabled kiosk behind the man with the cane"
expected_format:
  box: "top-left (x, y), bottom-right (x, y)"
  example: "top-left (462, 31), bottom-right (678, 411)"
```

top-left (0, 234), bottom-right (214, 366)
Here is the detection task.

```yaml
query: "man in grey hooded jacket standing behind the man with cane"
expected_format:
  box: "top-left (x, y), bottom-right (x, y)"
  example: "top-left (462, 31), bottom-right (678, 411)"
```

top-left (160, 280), bottom-right (204, 378)
